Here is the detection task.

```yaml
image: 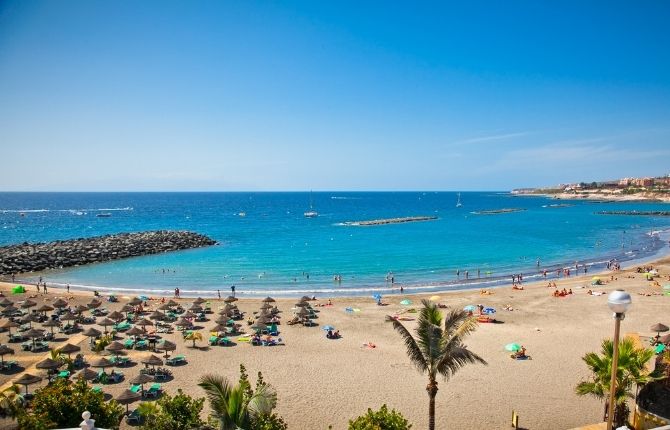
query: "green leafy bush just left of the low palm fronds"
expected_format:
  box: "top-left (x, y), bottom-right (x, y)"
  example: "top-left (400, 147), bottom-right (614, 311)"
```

top-left (138, 389), bottom-right (205, 430)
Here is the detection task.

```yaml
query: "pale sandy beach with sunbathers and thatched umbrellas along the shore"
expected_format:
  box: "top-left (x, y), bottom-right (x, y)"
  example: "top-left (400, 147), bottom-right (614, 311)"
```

top-left (0, 258), bottom-right (670, 429)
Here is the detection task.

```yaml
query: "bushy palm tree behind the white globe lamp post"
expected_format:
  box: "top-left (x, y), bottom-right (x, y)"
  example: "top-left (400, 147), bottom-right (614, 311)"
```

top-left (576, 337), bottom-right (663, 427)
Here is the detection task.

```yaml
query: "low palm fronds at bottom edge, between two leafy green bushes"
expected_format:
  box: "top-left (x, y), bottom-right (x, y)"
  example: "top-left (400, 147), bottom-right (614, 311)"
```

top-left (198, 374), bottom-right (277, 430)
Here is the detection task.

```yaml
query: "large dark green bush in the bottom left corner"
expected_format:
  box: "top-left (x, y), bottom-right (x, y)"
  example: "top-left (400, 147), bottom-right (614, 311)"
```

top-left (18, 379), bottom-right (123, 430)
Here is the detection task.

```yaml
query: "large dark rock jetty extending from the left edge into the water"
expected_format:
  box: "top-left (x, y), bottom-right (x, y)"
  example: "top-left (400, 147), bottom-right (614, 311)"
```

top-left (0, 230), bottom-right (216, 275)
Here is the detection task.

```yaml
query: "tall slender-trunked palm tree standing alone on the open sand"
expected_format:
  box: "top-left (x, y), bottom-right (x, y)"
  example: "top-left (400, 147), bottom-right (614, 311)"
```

top-left (390, 300), bottom-right (487, 430)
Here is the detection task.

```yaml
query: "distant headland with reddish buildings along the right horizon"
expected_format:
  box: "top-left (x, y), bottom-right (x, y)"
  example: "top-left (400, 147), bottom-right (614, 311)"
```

top-left (512, 175), bottom-right (670, 203)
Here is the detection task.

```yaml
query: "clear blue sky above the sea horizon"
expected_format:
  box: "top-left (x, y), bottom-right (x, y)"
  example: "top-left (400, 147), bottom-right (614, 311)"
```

top-left (0, 0), bottom-right (670, 191)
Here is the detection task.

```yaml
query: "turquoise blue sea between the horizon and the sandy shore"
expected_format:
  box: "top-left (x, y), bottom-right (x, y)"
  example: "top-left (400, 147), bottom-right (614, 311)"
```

top-left (0, 192), bottom-right (670, 297)
